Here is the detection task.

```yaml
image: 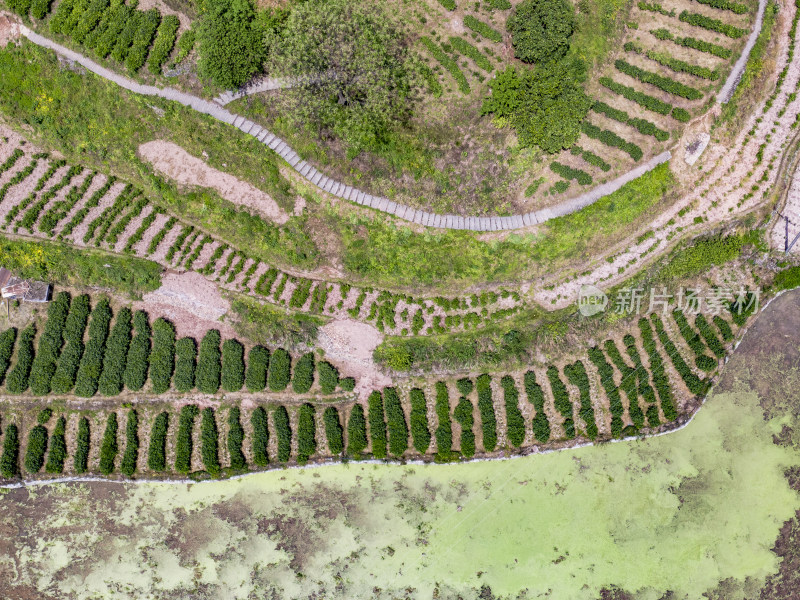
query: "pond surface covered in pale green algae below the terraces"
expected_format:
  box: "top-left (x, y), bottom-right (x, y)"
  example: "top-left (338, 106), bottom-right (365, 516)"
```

top-left (0, 292), bottom-right (800, 600)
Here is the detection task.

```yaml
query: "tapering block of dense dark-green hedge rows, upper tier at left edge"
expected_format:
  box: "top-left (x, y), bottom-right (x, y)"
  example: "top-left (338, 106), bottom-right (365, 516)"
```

top-left (0, 292), bottom-right (355, 397)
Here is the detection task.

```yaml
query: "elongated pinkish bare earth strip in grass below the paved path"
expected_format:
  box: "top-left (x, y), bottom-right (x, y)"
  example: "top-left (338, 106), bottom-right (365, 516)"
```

top-left (139, 140), bottom-right (289, 224)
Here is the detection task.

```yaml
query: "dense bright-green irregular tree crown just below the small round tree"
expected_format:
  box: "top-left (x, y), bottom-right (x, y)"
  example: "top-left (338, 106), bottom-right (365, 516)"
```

top-left (482, 59), bottom-right (592, 154)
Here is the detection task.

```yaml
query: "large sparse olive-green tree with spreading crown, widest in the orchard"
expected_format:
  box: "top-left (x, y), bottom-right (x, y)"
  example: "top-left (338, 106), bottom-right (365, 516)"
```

top-left (266, 0), bottom-right (415, 156)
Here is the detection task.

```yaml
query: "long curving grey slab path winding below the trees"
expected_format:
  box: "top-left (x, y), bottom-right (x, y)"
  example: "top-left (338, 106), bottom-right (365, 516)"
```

top-left (20, 29), bottom-right (672, 231)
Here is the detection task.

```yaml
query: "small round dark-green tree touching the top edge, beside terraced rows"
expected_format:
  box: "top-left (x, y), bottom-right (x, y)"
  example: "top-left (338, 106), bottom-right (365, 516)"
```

top-left (506, 0), bottom-right (575, 63)
